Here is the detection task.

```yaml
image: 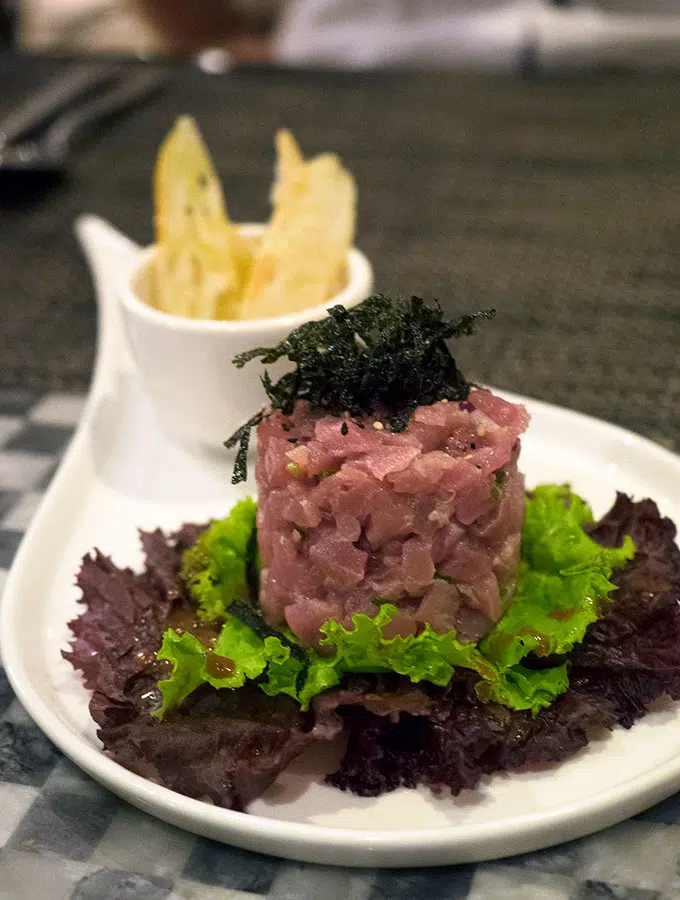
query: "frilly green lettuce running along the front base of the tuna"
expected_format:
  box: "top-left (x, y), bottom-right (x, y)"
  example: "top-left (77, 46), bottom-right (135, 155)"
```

top-left (156, 603), bottom-right (568, 717)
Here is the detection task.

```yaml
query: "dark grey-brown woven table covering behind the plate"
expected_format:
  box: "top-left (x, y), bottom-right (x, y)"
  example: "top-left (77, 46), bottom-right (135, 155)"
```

top-left (0, 57), bottom-right (680, 447)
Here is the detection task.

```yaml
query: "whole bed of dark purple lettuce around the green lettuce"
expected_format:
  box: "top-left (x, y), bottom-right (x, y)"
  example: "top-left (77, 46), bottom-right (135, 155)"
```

top-left (64, 495), bottom-right (680, 809)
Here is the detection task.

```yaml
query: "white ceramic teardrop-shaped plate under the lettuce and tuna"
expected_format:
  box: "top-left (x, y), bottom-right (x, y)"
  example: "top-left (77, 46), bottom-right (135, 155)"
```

top-left (1, 219), bottom-right (680, 866)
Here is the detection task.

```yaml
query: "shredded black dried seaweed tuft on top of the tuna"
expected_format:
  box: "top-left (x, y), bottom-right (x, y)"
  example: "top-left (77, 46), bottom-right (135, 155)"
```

top-left (225, 294), bottom-right (495, 484)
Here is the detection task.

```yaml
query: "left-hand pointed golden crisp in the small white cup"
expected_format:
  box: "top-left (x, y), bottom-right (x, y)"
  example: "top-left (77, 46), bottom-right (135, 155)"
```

top-left (152, 116), bottom-right (250, 319)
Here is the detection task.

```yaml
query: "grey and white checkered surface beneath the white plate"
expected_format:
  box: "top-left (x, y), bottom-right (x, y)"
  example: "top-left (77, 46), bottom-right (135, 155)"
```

top-left (0, 392), bottom-right (680, 900)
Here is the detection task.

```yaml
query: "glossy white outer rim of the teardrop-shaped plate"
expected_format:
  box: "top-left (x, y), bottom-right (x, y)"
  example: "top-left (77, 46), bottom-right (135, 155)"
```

top-left (0, 214), bottom-right (680, 867)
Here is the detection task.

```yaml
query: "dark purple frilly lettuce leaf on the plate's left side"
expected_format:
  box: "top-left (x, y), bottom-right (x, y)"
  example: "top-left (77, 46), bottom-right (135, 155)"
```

top-left (63, 526), bottom-right (313, 809)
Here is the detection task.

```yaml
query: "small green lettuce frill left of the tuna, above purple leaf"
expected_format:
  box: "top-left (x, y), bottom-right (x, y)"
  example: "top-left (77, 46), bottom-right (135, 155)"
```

top-left (181, 497), bottom-right (258, 621)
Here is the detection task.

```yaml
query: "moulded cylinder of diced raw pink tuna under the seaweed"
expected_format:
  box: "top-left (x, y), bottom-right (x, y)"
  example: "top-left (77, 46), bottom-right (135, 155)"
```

top-left (256, 390), bottom-right (529, 644)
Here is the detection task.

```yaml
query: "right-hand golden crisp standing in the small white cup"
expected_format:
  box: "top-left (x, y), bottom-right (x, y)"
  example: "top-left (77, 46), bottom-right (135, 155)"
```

top-left (240, 131), bottom-right (356, 318)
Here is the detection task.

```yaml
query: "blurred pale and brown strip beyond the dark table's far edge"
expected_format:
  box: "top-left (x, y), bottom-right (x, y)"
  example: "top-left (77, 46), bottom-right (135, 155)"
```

top-left (0, 0), bottom-right (680, 70)
